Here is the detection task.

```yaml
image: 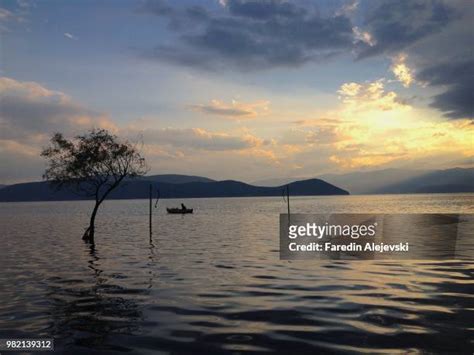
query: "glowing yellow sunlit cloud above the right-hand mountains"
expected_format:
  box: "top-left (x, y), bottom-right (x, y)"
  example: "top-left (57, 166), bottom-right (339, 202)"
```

top-left (262, 79), bottom-right (468, 175)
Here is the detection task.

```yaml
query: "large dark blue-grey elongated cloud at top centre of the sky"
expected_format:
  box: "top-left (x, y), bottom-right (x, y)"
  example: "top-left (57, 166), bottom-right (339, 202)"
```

top-left (142, 0), bottom-right (353, 70)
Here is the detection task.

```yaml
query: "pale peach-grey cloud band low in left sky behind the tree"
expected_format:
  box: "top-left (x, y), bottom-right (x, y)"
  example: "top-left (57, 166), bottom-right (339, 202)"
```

top-left (0, 77), bottom-right (278, 183)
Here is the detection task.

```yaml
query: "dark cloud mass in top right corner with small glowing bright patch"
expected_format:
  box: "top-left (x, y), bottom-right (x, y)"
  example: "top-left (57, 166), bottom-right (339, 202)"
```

top-left (357, 0), bottom-right (474, 120)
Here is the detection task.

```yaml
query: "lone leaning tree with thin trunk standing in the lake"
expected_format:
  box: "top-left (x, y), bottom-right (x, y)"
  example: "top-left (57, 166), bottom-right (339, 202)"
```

top-left (41, 129), bottom-right (147, 243)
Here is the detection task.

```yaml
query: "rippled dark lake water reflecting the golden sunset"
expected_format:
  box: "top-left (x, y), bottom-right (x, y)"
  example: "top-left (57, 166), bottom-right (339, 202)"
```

top-left (0, 194), bottom-right (474, 354)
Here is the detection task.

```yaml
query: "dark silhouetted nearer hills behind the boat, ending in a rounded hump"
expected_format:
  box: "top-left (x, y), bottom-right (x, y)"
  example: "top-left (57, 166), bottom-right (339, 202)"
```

top-left (0, 179), bottom-right (349, 202)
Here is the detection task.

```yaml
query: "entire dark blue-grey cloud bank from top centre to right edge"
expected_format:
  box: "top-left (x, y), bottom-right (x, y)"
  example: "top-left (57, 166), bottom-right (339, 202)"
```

top-left (141, 0), bottom-right (473, 119)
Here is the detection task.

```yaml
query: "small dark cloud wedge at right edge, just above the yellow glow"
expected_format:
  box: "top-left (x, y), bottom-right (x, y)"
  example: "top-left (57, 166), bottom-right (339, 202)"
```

top-left (417, 59), bottom-right (474, 119)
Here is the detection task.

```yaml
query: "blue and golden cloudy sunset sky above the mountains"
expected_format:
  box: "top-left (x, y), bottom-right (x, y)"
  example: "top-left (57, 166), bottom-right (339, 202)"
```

top-left (0, 0), bottom-right (474, 184)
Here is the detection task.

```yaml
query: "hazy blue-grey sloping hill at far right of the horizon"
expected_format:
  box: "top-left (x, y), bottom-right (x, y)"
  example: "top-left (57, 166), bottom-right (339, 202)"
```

top-left (374, 168), bottom-right (474, 194)
